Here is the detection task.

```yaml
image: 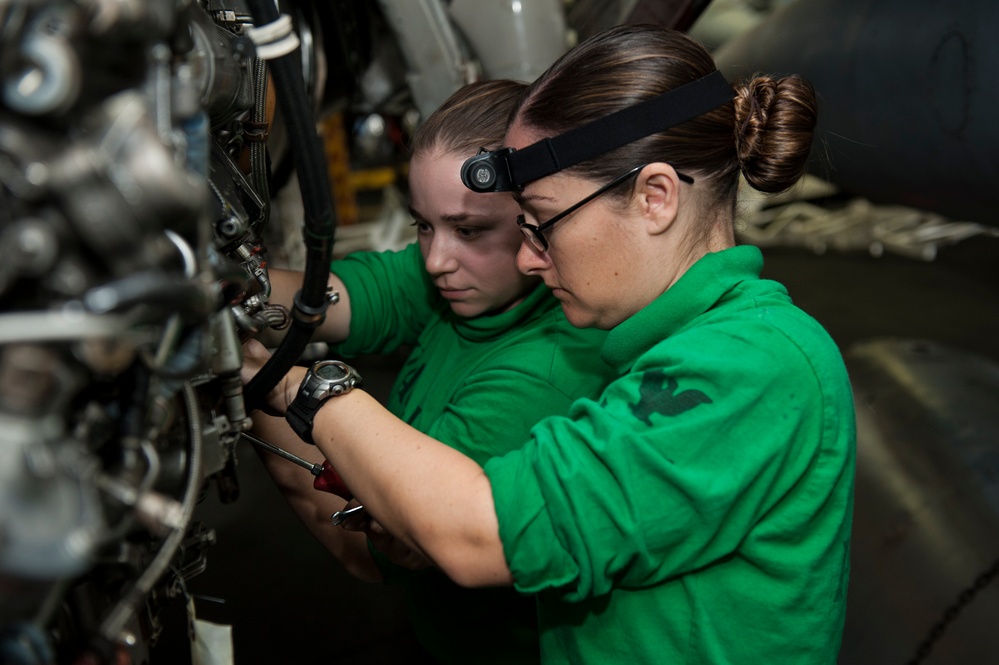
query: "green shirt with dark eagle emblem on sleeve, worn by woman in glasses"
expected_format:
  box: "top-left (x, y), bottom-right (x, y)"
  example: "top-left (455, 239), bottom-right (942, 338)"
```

top-left (485, 246), bottom-right (856, 665)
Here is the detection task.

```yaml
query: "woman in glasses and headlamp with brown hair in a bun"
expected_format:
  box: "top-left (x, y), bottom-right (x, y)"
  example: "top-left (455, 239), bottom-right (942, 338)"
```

top-left (244, 26), bottom-right (855, 665)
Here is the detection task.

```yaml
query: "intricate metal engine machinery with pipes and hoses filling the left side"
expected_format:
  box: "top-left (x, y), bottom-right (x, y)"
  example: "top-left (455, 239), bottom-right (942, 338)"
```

top-left (0, 0), bottom-right (565, 664)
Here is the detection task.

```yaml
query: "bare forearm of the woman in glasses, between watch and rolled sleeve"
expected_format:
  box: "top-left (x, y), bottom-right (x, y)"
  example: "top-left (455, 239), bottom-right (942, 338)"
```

top-left (313, 390), bottom-right (512, 586)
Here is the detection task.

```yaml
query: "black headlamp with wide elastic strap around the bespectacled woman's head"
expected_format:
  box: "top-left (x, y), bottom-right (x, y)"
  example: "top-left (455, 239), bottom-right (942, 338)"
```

top-left (461, 70), bottom-right (735, 193)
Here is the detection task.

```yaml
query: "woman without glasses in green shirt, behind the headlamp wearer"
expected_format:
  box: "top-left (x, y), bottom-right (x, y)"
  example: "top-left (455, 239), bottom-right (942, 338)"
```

top-left (254, 81), bottom-right (611, 664)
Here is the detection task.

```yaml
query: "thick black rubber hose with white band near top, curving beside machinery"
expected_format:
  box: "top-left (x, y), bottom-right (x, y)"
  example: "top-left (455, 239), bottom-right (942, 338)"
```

top-left (243, 0), bottom-right (336, 412)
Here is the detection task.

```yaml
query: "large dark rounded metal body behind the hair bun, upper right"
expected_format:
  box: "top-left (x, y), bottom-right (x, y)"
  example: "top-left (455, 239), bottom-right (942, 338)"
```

top-left (716, 0), bottom-right (999, 226)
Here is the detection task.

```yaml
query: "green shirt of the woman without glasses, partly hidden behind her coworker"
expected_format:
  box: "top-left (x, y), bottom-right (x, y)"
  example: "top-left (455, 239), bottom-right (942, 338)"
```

top-left (331, 245), bottom-right (613, 665)
